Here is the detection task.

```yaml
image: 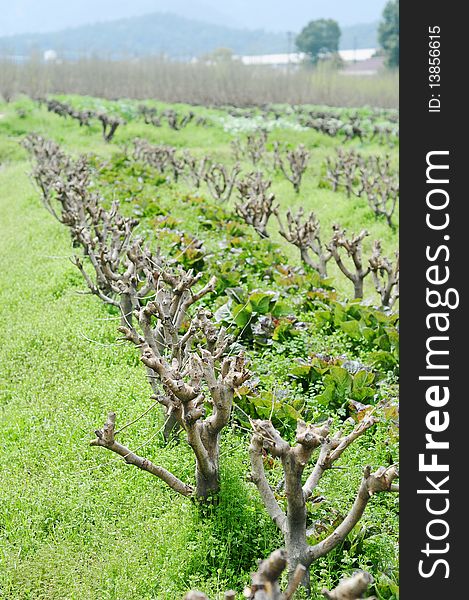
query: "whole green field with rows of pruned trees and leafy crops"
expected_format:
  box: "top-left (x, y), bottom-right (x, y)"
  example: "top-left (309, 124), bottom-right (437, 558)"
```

top-left (0, 96), bottom-right (399, 600)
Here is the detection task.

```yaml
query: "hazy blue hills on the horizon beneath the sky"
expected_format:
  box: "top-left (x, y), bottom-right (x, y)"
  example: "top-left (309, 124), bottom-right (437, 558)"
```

top-left (0, 13), bottom-right (377, 60)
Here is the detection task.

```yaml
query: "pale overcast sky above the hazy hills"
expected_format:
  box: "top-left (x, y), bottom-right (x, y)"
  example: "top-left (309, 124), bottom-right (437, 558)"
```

top-left (0, 0), bottom-right (386, 35)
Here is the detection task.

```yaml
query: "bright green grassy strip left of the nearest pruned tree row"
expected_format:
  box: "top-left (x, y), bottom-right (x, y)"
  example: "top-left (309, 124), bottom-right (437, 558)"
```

top-left (0, 162), bottom-right (269, 600)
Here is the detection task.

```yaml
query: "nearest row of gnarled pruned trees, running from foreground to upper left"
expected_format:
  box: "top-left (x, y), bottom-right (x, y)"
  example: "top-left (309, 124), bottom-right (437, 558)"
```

top-left (24, 135), bottom-right (398, 599)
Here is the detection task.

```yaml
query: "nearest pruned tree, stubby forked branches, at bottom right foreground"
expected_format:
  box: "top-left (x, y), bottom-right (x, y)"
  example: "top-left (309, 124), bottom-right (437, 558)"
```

top-left (249, 415), bottom-right (398, 586)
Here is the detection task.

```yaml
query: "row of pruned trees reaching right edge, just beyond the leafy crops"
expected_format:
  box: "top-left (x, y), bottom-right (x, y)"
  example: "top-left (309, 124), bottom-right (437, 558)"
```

top-left (133, 137), bottom-right (399, 308)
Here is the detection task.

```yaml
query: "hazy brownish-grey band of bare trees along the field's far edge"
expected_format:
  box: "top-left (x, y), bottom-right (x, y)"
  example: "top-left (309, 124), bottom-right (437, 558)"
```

top-left (0, 57), bottom-right (399, 108)
